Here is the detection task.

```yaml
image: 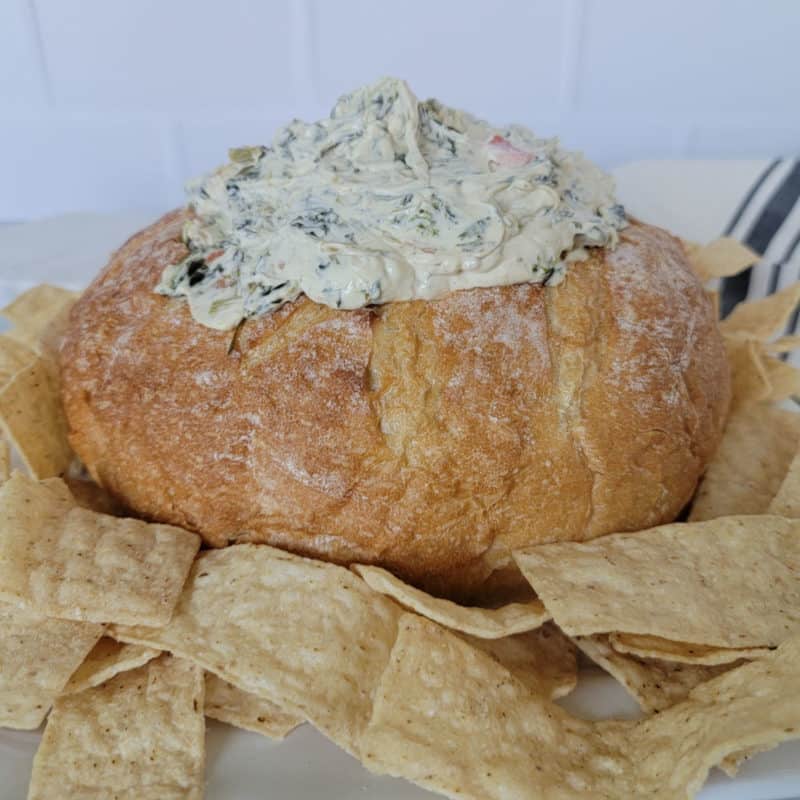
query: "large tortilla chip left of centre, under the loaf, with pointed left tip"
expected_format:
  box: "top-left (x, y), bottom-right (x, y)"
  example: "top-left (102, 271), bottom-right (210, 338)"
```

top-left (113, 544), bottom-right (401, 754)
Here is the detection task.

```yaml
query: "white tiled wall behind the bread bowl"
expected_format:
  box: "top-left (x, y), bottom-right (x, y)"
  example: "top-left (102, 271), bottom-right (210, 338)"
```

top-left (0, 0), bottom-right (800, 220)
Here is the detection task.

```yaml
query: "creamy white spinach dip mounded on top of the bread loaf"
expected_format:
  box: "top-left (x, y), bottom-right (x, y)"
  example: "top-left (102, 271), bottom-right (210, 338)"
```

top-left (156, 72), bottom-right (625, 330)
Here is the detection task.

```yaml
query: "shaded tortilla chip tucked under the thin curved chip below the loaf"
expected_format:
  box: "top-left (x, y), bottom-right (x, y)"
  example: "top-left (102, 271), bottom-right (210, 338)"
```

top-left (462, 622), bottom-right (578, 699)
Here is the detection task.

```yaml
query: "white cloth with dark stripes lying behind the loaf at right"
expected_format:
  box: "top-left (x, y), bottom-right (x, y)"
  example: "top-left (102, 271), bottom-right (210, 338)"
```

top-left (615, 158), bottom-right (800, 365)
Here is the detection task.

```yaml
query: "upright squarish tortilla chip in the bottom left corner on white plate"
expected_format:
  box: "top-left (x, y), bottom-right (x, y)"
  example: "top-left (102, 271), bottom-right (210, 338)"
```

top-left (28, 655), bottom-right (205, 800)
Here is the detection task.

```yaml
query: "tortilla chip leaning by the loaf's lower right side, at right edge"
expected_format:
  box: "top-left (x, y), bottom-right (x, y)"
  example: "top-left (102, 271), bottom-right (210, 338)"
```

top-left (689, 406), bottom-right (800, 522)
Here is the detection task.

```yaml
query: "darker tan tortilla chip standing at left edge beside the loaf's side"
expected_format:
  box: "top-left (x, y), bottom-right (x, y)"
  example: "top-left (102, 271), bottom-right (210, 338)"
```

top-left (0, 356), bottom-right (73, 478)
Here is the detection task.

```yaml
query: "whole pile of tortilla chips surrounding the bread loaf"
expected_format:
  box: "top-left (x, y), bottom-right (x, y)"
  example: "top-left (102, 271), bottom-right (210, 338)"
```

top-left (0, 253), bottom-right (800, 800)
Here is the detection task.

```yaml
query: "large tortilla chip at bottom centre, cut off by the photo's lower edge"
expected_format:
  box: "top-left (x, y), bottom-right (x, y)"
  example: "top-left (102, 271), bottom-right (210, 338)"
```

top-left (364, 614), bottom-right (608, 800)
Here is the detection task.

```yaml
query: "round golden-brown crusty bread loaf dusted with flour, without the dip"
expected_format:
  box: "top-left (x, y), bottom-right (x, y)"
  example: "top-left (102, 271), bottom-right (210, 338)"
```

top-left (62, 212), bottom-right (729, 597)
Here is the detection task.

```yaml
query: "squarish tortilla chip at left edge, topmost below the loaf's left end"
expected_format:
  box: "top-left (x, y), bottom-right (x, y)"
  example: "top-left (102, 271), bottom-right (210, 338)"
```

top-left (0, 472), bottom-right (200, 625)
